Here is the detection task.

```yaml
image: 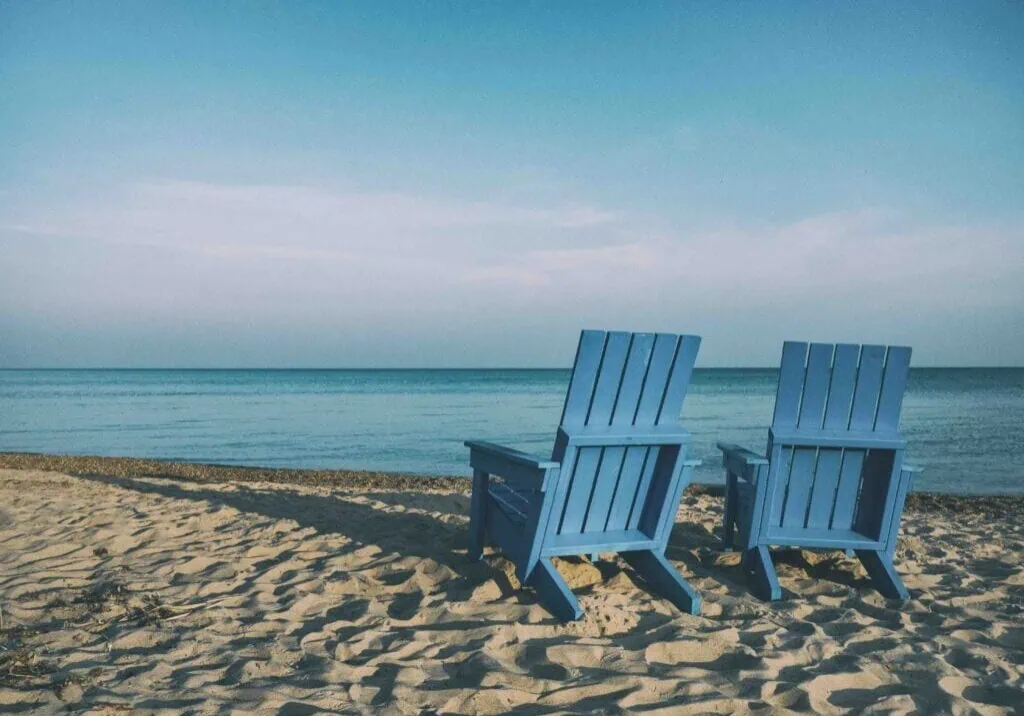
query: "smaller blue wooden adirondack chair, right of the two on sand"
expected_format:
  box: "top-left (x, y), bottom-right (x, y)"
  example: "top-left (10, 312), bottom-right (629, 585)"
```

top-left (718, 342), bottom-right (920, 600)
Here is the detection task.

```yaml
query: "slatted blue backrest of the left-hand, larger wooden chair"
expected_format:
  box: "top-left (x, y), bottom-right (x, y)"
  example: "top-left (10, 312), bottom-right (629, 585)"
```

top-left (552, 331), bottom-right (700, 535)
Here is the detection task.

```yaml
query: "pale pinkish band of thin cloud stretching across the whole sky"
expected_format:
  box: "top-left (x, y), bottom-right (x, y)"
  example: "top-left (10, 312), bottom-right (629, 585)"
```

top-left (5, 181), bottom-right (1024, 333)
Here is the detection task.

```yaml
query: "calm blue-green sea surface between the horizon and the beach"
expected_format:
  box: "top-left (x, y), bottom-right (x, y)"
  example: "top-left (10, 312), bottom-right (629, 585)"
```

top-left (0, 369), bottom-right (1024, 493)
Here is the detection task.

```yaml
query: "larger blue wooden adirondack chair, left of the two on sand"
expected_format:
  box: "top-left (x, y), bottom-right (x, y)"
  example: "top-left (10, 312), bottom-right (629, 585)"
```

top-left (465, 331), bottom-right (700, 621)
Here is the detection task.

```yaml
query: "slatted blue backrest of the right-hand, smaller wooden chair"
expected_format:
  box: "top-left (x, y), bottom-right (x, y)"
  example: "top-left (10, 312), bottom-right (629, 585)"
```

top-left (764, 342), bottom-right (910, 539)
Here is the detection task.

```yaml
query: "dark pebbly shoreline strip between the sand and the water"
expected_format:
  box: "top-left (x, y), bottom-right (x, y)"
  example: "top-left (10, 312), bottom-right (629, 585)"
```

top-left (0, 452), bottom-right (1024, 517)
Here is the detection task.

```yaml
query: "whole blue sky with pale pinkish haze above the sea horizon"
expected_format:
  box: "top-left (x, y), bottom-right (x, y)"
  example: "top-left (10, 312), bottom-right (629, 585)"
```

top-left (0, 0), bottom-right (1024, 368)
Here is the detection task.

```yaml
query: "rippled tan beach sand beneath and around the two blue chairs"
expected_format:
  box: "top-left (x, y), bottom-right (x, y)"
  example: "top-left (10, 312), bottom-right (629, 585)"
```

top-left (0, 455), bottom-right (1024, 714)
